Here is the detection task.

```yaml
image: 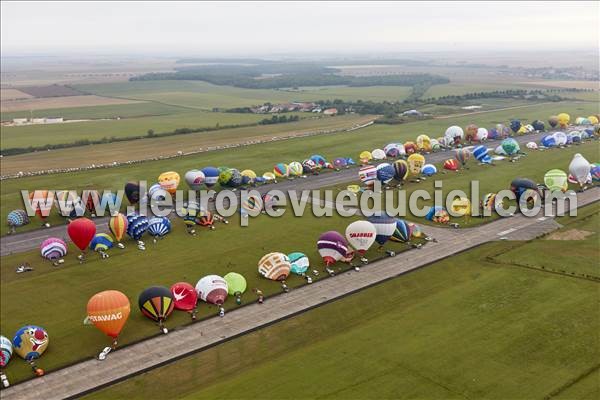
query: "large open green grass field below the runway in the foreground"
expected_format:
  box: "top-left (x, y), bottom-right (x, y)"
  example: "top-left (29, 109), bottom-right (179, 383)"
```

top-left (87, 205), bottom-right (600, 399)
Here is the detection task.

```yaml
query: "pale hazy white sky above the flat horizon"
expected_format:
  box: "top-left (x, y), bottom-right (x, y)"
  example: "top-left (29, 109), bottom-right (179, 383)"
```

top-left (1, 1), bottom-right (600, 56)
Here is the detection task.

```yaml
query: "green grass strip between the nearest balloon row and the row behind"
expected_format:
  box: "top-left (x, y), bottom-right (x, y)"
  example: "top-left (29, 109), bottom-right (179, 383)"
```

top-left (0, 206), bottom-right (418, 382)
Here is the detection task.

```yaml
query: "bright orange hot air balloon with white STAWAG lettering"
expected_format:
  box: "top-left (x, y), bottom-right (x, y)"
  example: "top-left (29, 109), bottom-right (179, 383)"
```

top-left (87, 290), bottom-right (131, 347)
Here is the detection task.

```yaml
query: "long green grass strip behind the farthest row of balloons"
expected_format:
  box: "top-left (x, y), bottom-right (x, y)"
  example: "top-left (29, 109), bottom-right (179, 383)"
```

top-left (0, 103), bottom-right (595, 234)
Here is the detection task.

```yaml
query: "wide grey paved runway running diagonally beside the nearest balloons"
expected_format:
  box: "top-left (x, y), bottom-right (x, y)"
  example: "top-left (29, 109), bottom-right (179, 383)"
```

top-left (2, 187), bottom-right (600, 400)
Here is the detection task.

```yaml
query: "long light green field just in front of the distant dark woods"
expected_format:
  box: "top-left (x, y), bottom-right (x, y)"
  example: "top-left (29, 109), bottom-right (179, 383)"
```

top-left (76, 81), bottom-right (411, 110)
